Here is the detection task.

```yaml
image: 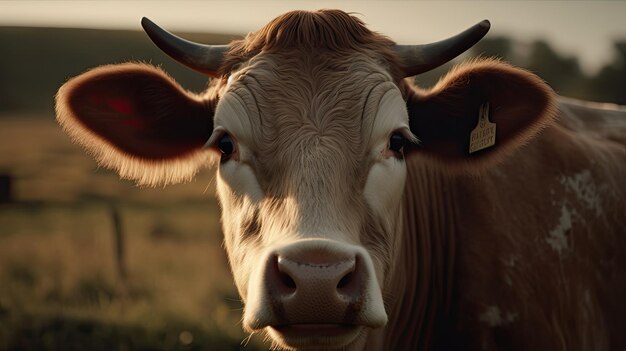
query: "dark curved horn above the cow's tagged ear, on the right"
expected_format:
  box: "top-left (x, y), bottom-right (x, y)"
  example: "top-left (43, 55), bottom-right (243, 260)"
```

top-left (394, 20), bottom-right (491, 77)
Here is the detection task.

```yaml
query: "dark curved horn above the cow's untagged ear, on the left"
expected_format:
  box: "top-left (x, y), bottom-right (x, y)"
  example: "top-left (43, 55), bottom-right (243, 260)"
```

top-left (141, 17), bottom-right (228, 77)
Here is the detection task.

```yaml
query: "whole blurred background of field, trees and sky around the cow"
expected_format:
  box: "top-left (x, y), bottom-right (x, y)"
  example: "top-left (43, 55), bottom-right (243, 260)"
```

top-left (0, 1), bottom-right (626, 350)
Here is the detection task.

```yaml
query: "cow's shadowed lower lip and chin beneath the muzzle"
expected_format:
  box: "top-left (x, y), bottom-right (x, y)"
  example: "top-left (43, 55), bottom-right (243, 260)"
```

top-left (269, 323), bottom-right (363, 349)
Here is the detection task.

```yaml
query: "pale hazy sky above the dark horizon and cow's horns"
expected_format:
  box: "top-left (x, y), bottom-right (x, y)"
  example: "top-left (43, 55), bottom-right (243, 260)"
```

top-left (0, 0), bottom-right (626, 73)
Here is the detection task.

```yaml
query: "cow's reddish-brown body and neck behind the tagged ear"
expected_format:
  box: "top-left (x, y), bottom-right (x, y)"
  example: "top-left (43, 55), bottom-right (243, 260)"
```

top-left (392, 99), bottom-right (626, 350)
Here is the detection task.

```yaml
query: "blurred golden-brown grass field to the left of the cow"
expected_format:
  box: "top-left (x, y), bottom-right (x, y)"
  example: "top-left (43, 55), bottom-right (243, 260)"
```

top-left (0, 117), bottom-right (260, 350)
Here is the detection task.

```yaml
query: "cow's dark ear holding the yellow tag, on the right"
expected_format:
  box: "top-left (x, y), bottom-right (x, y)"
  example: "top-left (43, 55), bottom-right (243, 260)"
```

top-left (407, 60), bottom-right (557, 173)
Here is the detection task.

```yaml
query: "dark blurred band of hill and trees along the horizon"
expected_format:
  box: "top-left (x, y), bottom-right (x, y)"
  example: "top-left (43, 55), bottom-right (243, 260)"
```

top-left (0, 27), bottom-right (626, 117)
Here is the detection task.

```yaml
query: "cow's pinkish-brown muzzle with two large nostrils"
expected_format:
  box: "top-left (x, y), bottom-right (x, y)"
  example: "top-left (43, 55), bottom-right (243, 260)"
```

top-left (244, 239), bottom-right (387, 346)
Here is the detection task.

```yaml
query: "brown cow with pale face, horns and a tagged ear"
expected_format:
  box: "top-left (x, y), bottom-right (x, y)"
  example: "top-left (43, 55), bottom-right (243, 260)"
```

top-left (56, 10), bottom-right (626, 350)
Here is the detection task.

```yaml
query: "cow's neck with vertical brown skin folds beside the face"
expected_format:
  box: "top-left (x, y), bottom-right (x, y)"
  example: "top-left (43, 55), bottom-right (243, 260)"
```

top-left (384, 159), bottom-right (458, 350)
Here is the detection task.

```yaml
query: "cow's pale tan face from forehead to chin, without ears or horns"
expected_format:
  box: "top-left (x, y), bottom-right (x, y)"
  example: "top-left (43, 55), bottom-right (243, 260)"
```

top-left (209, 52), bottom-right (413, 348)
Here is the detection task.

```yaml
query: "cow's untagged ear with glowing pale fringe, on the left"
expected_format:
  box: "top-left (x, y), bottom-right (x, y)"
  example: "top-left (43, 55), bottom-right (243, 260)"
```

top-left (56, 63), bottom-right (217, 186)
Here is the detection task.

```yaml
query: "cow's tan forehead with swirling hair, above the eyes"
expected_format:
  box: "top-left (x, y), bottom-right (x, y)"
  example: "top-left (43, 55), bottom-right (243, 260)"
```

top-left (215, 50), bottom-right (399, 149)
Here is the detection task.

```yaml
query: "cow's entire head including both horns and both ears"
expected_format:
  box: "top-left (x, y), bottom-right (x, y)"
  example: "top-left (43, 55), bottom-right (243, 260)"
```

top-left (57, 11), bottom-right (551, 349)
